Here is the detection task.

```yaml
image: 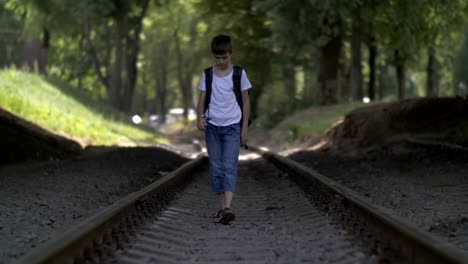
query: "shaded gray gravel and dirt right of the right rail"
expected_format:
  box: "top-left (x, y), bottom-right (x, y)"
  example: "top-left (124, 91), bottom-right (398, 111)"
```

top-left (289, 142), bottom-right (468, 250)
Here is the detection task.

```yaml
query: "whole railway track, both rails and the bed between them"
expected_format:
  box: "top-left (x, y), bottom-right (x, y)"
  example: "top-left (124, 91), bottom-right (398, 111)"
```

top-left (13, 147), bottom-right (468, 263)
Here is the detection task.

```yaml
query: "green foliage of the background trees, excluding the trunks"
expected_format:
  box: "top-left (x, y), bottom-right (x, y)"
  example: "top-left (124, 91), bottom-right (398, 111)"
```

top-left (0, 0), bottom-right (468, 127)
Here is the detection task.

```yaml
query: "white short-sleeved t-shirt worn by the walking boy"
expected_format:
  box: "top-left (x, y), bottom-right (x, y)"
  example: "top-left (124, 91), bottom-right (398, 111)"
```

top-left (199, 69), bottom-right (252, 126)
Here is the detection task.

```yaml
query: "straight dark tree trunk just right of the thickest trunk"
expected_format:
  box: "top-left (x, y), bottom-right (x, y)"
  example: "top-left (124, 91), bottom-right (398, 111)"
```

top-left (351, 11), bottom-right (363, 101)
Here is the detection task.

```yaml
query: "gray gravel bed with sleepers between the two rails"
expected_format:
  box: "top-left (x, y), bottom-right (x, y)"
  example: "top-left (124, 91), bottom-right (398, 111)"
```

top-left (111, 159), bottom-right (378, 264)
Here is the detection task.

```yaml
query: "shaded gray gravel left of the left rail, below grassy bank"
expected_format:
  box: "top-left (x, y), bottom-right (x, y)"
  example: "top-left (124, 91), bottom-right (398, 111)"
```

top-left (0, 148), bottom-right (187, 263)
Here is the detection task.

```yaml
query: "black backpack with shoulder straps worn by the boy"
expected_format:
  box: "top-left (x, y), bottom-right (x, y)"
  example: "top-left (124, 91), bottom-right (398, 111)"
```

top-left (203, 65), bottom-right (252, 127)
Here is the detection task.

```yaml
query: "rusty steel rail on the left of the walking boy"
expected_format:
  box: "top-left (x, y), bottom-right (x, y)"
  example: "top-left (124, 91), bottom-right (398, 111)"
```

top-left (15, 155), bottom-right (207, 264)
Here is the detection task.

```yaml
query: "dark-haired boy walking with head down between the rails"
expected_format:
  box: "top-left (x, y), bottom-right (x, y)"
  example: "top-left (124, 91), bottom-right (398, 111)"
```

top-left (197, 35), bottom-right (252, 224)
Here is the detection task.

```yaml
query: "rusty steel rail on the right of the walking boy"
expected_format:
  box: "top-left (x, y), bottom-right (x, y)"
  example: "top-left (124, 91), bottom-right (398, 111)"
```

top-left (250, 146), bottom-right (468, 264)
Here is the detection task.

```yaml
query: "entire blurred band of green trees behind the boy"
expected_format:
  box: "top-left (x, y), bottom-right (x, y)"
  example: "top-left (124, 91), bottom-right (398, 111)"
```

top-left (0, 0), bottom-right (468, 125)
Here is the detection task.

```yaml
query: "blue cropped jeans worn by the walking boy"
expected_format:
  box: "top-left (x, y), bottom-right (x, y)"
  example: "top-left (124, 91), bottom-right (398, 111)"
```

top-left (205, 123), bottom-right (240, 193)
